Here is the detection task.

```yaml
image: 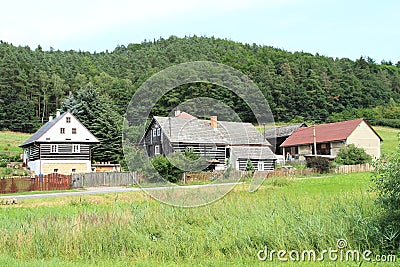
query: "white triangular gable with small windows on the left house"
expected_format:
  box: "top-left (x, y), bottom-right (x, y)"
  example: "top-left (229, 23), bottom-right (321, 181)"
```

top-left (37, 112), bottom-right (99, 143)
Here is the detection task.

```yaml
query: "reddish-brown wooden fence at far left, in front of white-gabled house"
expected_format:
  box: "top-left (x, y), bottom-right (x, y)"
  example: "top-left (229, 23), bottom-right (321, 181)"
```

top-left (0, 173), bottom-right (72, 194)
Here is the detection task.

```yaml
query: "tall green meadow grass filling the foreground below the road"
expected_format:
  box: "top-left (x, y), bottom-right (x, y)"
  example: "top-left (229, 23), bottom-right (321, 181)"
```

top-left (0, 173), bottom-right (396, 266)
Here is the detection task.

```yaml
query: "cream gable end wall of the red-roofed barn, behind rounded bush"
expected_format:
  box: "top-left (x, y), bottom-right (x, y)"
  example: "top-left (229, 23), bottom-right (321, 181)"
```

top-left (346, 121), bottom-right (381, 158)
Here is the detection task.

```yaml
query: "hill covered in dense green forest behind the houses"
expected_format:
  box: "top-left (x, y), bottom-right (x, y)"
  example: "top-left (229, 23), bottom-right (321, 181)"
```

top-left (0, 36), bottom-right (400, 132)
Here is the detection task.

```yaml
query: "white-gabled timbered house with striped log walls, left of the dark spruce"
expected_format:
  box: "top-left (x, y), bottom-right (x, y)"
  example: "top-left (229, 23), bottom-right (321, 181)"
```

top-left (20, 112), bottom-right (99, 175)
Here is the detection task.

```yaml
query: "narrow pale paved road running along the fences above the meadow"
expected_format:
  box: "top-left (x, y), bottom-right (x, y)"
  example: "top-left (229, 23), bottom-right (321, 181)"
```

top-left (0, 182), bottom-right (241, 199)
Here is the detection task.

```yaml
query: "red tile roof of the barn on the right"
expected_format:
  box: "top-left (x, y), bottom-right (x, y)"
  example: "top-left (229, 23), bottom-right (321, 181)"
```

top-left (281, 119), bottom-right (382, 147)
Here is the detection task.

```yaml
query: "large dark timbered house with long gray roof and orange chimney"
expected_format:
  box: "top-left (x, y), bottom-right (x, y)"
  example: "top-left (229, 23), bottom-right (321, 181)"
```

top-left (141, 113), bottom-right (276, 171)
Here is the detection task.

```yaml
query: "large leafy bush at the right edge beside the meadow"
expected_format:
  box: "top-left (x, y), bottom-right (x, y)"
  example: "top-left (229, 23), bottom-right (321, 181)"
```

top-left (372, 144), bottom-right (400, 250)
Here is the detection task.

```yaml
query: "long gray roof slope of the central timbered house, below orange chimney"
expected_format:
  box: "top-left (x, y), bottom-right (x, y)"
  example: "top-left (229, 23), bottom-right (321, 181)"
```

top-left (154, 116), bottom-right (270, 146)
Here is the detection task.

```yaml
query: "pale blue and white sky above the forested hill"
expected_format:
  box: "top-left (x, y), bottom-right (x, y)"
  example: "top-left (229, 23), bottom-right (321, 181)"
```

top-left (0, 0), bottom-right (400, 63)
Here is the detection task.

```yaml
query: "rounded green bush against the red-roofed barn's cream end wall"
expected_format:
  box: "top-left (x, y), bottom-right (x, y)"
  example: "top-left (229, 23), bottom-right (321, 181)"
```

top-left (335, 144), bottom-right (372, 165)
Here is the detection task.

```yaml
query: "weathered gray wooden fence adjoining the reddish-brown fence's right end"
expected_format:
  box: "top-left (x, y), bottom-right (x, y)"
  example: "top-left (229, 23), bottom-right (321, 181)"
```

top-left (71, 172), bottom-right (137, 188)
